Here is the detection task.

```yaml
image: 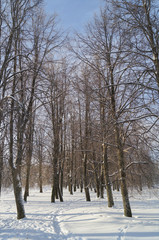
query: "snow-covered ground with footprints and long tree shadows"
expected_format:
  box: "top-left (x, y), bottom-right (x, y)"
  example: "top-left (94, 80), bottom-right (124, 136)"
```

top-left (0, 187), bottom-right (159, 240)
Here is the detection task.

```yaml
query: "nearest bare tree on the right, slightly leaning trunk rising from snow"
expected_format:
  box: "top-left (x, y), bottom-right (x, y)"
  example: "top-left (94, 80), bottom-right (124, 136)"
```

top-left (71, 7), bottom-right (136, 217)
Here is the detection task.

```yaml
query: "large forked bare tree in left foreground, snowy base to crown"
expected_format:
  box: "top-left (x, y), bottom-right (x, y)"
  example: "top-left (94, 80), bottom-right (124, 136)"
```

top-left (4, 0), bottom-right (60, 219)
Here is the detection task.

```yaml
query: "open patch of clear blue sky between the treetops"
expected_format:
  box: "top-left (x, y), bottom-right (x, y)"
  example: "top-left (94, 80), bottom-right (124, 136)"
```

top-left (44, 0), bottom-right (104, 30)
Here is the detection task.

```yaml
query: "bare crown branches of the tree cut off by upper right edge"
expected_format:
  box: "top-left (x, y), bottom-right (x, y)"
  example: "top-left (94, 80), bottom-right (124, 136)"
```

top-left (112, 0), bottom-right (159, 86)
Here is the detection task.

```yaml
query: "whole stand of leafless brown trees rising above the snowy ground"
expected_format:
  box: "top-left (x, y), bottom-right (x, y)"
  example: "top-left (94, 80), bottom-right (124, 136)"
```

top-left (0, 0), bottom-right (159, 231)
